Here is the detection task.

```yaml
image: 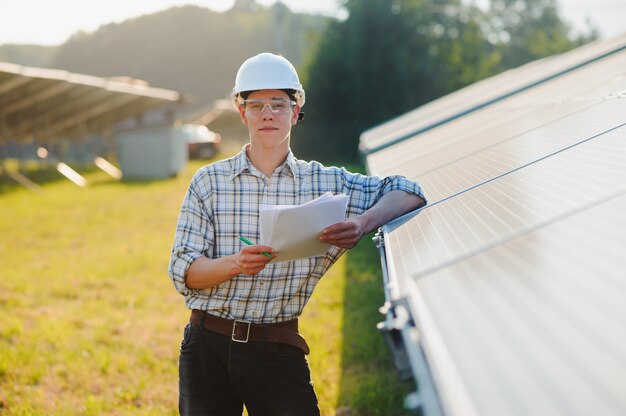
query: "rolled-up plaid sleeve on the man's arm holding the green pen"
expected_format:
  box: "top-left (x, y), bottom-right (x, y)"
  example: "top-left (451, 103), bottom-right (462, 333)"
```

top-left (168, 176), bottom-right (214, 296)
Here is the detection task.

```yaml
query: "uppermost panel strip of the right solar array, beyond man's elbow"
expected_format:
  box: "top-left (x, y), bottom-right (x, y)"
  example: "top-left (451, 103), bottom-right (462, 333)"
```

top-left (367, 53), bottom-right (626, 193)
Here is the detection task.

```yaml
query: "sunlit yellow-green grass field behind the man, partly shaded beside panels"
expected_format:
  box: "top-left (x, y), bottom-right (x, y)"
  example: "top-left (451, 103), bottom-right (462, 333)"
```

top-left (0, 154), bottom-right (410, 416)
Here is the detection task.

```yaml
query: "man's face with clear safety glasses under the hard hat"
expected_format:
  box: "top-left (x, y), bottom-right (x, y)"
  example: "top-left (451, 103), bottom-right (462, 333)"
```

top-left (239, 90), bottom-right (300, 147)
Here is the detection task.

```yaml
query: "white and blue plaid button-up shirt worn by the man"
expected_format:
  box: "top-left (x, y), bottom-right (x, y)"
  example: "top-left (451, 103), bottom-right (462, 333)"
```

top-left (169, 147), bottom-right (426, 323)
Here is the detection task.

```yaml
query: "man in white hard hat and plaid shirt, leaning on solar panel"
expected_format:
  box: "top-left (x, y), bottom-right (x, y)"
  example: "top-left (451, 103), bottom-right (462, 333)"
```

top-left (169, 53), bottom-right (426, 416)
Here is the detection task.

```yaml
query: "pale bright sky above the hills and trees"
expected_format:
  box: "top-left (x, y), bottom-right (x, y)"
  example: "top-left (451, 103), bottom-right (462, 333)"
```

top-left (0, 0), bottom-right (626, 45)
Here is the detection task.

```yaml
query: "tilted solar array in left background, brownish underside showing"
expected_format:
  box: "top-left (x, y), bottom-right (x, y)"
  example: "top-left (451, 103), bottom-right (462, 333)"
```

top-left (0, 62), bottom-right (181, 143)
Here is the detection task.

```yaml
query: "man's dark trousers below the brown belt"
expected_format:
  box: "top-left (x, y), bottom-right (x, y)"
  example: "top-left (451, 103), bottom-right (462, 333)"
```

top-left (178, 323), bottom-right (320, 416)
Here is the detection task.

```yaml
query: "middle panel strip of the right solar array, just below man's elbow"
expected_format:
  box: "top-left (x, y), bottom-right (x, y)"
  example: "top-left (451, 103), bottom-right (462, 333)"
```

top-left (385, 124), bottom-right (626, 290)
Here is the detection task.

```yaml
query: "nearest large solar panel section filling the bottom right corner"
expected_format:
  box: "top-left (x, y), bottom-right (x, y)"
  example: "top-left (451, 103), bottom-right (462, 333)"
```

top-left (409, 193), bottom-right (626, 415)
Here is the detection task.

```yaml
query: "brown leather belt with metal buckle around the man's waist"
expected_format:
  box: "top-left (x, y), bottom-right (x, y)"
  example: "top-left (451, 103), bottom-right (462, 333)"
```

top-left (189, 309), bottom-right (309, 354)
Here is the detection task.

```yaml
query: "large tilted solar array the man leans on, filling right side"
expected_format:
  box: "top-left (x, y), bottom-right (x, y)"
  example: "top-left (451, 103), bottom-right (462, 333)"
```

top-left (360, 36), bottom-right (626, 415)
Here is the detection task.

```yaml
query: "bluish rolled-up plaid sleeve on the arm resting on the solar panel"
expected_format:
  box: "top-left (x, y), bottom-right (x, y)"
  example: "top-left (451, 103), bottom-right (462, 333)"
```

top-left (342, 169), bottom-right (426, 216)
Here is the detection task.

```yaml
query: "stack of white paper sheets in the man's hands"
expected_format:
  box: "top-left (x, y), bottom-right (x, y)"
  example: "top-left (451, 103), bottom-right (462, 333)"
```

top-left (259, 192), bottom-right (348, 262)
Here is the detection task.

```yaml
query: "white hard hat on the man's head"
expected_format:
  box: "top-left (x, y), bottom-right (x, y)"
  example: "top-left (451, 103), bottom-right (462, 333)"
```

top-left (231, 53), bottom-right (304, 107)
